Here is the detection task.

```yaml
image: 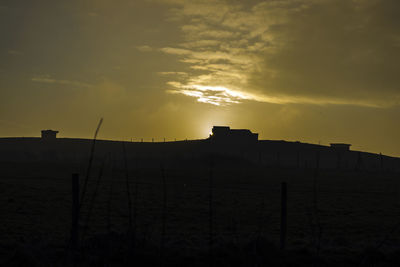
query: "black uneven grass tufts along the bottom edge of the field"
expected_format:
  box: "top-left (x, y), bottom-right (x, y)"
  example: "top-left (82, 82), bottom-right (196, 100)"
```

top-left (0, 236), bottom-right (400, 267)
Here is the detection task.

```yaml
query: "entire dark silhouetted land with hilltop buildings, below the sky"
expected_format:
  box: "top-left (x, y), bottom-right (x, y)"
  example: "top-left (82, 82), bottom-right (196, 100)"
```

top-left (0, 127), bottom-right (400, 266)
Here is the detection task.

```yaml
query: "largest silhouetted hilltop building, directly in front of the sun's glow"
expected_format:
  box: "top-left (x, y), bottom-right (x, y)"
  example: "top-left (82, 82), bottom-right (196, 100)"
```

top-left (210, 126), bottom-right (258, 144)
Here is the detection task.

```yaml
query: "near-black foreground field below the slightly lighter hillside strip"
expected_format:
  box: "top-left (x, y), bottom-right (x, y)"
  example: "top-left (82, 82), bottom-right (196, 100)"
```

top-left (0, 158), bottom-right (400, 266)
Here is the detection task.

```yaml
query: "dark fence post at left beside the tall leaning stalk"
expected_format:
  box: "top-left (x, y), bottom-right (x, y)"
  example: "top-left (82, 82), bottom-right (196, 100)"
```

top-left (71, 173), bottom-right (79, 249)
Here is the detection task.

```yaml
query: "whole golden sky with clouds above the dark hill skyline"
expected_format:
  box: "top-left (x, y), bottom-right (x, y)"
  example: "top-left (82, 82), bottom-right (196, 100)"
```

top-left (0, 0), bottom-right (400, 156)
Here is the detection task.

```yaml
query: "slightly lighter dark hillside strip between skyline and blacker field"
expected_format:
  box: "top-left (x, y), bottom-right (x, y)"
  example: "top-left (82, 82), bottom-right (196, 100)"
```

top-left (0, 138), bottom-right (400, 172)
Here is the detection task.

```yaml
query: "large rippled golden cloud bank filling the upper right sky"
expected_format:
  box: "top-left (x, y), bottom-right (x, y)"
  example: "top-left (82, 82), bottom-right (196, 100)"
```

top-left (160, 0), bottom-right (400, 107)
